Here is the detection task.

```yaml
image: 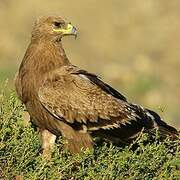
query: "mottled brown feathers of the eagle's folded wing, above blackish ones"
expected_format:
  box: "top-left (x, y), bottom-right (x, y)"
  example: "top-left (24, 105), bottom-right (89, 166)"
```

top-left (38, 66), bottom-right (136, 129)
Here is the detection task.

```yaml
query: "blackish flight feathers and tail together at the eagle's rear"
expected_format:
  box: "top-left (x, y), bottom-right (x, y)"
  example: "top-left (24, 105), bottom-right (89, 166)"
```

top-left (92, 104), bottom-right (178, 145)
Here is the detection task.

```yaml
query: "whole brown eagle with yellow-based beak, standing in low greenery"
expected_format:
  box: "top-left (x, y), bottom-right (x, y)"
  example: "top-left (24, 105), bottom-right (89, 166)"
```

top-left (16, 16), bottom-right (177, 155)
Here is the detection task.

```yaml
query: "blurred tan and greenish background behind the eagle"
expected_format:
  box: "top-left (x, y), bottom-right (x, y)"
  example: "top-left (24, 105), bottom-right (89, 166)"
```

top-left (0, 0), bottom-right (180, 128)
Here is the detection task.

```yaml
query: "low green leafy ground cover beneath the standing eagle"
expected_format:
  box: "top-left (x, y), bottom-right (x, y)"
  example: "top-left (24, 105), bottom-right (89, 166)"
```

top-left (0, 93), bottom-right (180, 180)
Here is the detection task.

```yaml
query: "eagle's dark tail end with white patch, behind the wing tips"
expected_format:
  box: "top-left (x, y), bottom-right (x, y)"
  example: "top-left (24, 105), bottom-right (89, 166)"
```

top-left (146, 109), bottom-right (179, 140)
